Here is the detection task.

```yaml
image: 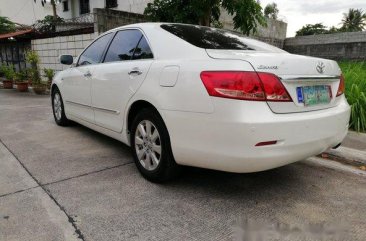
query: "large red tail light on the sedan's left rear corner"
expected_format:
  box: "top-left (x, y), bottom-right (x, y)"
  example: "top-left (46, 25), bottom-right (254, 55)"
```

top-left (201, 71), bottom-right (292, 101)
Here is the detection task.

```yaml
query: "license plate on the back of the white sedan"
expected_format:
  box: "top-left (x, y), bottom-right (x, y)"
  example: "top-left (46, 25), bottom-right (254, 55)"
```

top-left (297, 85), bottom-right (332, 106)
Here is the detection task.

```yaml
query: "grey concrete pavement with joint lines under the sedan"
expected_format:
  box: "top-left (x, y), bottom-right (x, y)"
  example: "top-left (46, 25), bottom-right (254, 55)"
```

top-left (0, 90), bottom-right (366, 241)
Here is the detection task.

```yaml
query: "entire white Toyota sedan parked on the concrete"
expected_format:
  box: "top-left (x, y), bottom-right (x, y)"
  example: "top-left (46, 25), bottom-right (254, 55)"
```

top-left (51, 23), bottom-right (350, 182)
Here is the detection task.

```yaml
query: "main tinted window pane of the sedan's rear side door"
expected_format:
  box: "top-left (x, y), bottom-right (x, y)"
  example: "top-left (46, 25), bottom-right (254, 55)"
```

top-left (104, 30), bottom-right (142, 62)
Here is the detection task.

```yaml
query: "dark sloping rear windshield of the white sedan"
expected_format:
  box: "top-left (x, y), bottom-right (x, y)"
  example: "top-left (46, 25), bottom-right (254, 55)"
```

top-left (161, 24), bottom-right (282, 52)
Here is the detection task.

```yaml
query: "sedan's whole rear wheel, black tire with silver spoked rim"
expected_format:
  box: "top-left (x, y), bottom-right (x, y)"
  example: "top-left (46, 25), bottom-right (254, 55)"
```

top-left (130, 108), bottom-right (180, 183)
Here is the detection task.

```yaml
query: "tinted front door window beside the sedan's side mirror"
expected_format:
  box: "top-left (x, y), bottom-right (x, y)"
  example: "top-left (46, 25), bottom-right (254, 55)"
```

top-left (78, 33), bottom-right (113, 65)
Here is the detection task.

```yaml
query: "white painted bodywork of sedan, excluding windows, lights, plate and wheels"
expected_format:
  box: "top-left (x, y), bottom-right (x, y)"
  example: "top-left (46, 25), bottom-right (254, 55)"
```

top-left (52, 23), bottom-right (350, 173)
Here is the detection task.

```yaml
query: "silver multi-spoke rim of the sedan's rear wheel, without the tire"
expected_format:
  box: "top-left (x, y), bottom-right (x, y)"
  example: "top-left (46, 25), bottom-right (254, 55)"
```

top-left (135, 120), bottom-right (161, 171)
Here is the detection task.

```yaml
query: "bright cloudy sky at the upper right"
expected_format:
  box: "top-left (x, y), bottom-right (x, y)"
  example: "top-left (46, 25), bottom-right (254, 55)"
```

top-left (260, 0), bottom-right (366, 37)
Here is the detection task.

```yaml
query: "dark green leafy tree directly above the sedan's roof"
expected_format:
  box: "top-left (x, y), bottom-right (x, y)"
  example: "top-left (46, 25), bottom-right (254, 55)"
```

top-left (144, 0), bottom-right (266, 35)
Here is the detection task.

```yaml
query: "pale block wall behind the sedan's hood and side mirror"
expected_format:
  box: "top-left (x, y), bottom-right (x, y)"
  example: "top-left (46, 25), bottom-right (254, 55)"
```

top-left (32, 33), bottom-right (97, 74)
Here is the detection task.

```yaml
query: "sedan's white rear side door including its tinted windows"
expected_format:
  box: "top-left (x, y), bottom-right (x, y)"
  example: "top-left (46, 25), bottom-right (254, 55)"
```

top-left (91, 29), bottom-right (153, 132)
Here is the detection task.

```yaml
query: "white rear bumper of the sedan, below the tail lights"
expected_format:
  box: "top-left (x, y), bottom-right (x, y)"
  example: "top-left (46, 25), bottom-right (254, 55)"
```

top-left (162, 97), bottom-right (350, 173)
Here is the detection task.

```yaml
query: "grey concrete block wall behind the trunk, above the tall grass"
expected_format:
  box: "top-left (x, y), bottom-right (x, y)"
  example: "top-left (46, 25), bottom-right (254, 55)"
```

top-left (284, 32), bottom-right (366, 60)
